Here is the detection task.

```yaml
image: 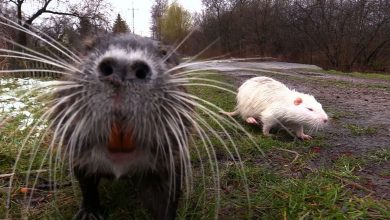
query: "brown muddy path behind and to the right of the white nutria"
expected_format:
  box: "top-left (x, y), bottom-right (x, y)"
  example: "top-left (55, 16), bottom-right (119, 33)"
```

top-left (200, 62), bottom-right (390, 199)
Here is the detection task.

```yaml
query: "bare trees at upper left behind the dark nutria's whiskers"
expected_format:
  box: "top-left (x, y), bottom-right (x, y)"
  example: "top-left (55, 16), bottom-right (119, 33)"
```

top-left (0, 0), bottom-right (134, 77)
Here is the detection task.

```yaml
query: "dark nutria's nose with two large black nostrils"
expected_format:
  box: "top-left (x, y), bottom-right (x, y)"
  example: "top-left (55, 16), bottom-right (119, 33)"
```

top-left (98, 58), bottom-right (151, 83)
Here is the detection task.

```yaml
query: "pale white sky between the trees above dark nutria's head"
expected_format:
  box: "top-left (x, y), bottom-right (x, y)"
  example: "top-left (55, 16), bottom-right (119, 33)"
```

top-left (108, 0), bottom-right (202, 36)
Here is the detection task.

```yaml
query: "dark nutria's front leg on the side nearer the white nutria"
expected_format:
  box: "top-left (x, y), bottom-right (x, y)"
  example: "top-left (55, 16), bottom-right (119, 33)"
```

top-left (139, 171), bottom-right (181, 220)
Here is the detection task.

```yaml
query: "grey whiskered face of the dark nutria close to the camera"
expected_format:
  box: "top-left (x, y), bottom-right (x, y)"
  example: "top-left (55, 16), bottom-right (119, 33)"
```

top-left (53, 35), bottom-right (190, 172)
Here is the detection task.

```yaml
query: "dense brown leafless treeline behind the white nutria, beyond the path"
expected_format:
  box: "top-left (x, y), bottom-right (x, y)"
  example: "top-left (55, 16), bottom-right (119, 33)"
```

top-left (152, 0), bottom-right (390, 72)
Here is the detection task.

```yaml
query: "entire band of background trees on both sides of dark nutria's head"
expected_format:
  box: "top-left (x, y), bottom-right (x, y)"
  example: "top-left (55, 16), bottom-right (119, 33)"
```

top-left (0, 0), bottom-right (390, 72)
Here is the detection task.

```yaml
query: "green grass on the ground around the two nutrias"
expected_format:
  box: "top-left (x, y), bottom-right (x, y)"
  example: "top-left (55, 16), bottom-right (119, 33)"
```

top-left (0, 75), bottom-right (390, 219)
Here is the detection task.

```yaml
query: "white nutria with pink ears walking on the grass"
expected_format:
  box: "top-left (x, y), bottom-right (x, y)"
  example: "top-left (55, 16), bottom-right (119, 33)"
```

top-left (221, 77), bottom-right (328, 140)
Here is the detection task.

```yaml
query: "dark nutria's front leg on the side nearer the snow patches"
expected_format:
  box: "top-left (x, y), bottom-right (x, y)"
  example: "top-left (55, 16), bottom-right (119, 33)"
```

top-left (74, 167), bottom-right (104, 220)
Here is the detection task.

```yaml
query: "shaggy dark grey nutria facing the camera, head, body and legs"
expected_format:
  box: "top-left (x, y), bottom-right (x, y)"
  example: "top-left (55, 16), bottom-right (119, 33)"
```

top-left (52, 34), bottom-right (192, 219)
